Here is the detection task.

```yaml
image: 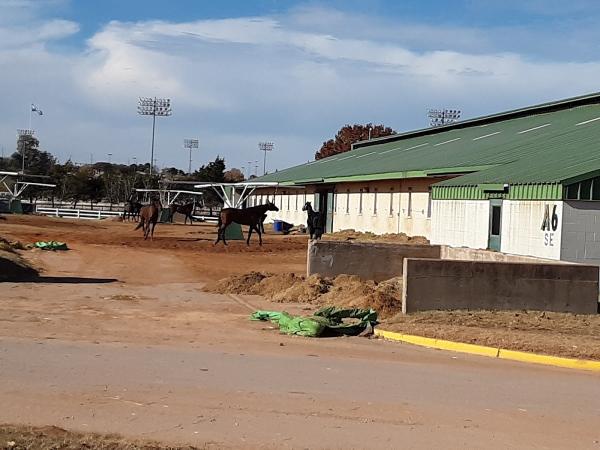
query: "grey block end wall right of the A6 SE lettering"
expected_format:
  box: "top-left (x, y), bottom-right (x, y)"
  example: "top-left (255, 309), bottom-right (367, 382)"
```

top-left (561, 200), bottom-right (600, 265)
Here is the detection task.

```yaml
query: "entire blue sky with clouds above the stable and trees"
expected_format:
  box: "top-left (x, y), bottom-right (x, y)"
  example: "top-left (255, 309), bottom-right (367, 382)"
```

top-left (0, 0), bottom-right (600, 175)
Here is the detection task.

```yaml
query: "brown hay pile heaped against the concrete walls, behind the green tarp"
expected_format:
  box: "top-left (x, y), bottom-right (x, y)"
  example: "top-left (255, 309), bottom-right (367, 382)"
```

top-left (205, 272), bottom-right (402, 318)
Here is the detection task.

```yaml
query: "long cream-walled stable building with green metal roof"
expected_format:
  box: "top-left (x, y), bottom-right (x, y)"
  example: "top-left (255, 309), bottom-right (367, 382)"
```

top-left (249, 93), bottom-right (600, 264)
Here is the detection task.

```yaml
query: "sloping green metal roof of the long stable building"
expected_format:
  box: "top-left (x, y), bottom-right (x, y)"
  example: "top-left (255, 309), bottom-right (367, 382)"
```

top-left (257, 93), bottom-right (600, 186)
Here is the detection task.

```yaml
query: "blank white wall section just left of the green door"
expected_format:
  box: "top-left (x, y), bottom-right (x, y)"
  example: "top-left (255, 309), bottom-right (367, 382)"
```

top-left (431, 200), bottom-right (490, 248)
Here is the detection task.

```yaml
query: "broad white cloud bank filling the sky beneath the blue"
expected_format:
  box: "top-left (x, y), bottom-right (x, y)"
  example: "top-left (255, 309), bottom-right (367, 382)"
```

top-left (0, 8), bottom-right (600, 172)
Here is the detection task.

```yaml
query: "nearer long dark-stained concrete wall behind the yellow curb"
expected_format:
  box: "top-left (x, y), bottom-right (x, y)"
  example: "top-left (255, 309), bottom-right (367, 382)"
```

top-left (402, 258), bottom-right (598, 314)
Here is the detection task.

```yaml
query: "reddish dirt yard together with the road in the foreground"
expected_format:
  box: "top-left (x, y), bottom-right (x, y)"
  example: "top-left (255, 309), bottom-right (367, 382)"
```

top-left (0, 217), bottom-right (600, 449)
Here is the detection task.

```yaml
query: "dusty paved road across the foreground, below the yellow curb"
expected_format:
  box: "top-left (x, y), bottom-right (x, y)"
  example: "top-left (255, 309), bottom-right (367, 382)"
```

top-left (0, 338), bottom-right (600, 449)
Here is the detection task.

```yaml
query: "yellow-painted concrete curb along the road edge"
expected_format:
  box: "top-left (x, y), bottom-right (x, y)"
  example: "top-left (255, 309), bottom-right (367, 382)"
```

top-left (375, 328), bottom-right (600, 372)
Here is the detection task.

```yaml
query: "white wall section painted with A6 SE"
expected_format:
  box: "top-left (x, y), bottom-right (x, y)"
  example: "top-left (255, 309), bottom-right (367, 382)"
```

top-left (500, 200), bottom-right (563, 260)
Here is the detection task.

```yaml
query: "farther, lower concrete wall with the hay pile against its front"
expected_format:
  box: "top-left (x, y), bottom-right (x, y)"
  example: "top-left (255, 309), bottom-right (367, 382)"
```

top-left (307, 241), bottom-right (441, 281)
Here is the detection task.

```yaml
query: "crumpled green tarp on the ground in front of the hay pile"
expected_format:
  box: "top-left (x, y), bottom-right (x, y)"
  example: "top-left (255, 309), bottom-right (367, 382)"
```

top-left (250, 306), bottom-right (378, 337)
